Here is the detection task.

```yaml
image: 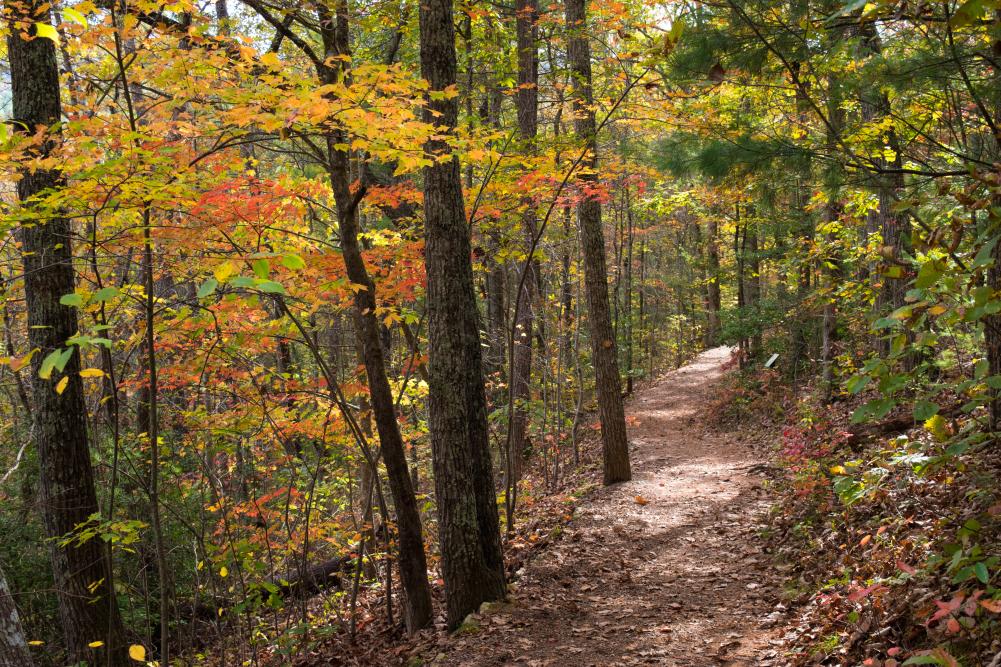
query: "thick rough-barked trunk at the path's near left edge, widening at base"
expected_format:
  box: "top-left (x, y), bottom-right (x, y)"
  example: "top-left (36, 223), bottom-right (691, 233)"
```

top-left (419, 0), bottom-right (505, 628)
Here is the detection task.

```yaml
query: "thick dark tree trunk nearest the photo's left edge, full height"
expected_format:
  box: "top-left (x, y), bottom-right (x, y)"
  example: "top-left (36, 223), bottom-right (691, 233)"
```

top-left (6, 0), bottom-right (128, 665)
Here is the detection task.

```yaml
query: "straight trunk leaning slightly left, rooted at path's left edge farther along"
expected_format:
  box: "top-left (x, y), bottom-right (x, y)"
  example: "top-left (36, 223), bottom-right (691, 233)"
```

top-left (566, 0), bottom-right (633, 484)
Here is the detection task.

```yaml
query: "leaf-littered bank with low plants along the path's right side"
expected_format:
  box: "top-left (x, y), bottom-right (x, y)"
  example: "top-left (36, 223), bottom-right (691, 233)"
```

top-left (709, 360), bottom-right (1001, 667)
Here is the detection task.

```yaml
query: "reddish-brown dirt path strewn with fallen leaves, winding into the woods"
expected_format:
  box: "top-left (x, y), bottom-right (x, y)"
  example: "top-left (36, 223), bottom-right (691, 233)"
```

top-left (432, 348), bottom-right (780, 667)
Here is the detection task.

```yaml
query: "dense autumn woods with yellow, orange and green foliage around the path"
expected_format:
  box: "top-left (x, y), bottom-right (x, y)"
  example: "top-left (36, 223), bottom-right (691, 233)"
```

top-left (0, 0), bottom-right (1001, 665)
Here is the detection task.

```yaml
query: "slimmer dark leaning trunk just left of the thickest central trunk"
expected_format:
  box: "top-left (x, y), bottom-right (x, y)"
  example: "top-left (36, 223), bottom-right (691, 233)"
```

top-left (320, 0), bottom-right (433, 633)
